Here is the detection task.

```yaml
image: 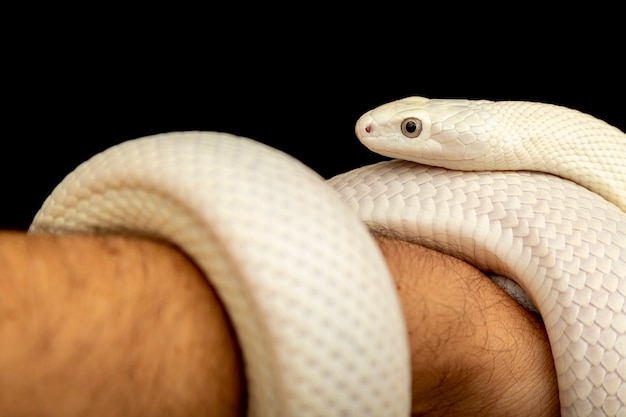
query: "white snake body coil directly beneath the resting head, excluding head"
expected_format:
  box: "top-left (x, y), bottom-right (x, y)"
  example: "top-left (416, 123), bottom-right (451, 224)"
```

top-left (329, 159), bottom-right (626, 417)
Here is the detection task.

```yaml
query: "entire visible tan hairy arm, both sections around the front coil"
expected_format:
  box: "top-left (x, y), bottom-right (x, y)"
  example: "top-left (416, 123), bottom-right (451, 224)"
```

top-left (0, 232), bottom-right (559, 416)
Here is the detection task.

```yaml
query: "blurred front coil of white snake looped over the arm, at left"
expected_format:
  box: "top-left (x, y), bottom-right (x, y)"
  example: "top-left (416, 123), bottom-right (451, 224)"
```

top-left (30, 132), bottom-right (411, 417)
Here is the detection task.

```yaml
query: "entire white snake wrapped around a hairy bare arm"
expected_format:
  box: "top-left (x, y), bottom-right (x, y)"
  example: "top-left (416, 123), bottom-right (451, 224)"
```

top-left (30, 98), bottom-right (626, 416)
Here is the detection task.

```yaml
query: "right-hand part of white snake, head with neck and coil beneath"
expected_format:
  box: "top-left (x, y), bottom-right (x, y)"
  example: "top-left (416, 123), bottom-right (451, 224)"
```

top-left (338, 97), bottom-right (626, 416)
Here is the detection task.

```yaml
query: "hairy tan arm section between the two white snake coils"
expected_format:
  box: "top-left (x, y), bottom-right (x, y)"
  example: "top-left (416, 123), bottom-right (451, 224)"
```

top-left (378, 236), bottom-right (560, 416)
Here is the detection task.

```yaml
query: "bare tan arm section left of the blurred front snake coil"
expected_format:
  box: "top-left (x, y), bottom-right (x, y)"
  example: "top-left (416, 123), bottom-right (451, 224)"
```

top-left (0, 233), bottom-right (244, 416)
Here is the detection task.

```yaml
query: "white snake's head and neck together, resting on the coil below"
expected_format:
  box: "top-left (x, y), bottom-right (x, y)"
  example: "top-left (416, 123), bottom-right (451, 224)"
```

top-left (355, 97), bottom-right (626, 211)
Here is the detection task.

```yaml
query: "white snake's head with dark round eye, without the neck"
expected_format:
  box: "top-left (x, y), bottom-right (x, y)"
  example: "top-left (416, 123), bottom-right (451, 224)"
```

top-left (355, 96), bottom-right (492, 169)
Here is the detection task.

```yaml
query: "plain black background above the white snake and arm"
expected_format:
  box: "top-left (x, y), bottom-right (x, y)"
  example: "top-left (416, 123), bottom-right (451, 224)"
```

top-left (0, 11), bottom-right (626, 230)
